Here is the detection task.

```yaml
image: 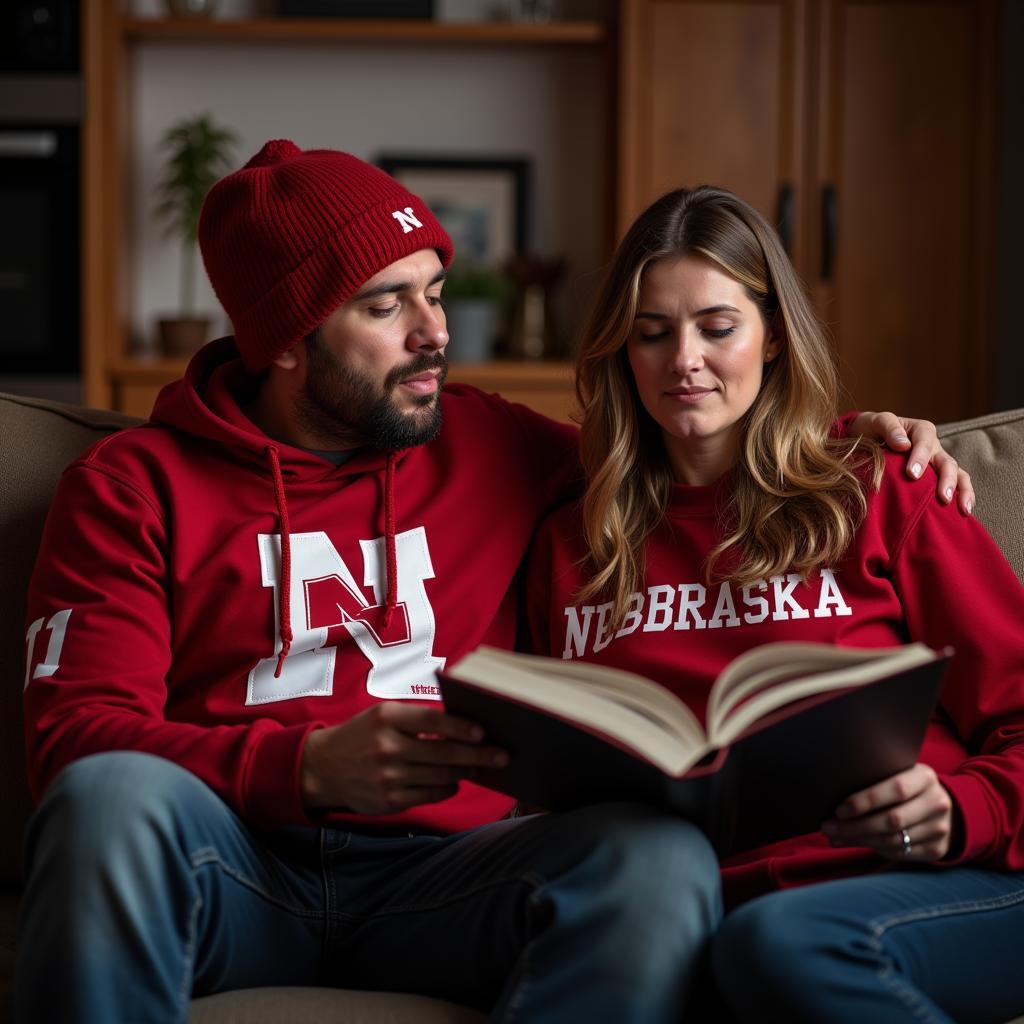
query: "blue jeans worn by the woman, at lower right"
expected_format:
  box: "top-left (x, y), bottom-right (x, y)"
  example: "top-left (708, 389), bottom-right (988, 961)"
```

top-left (712, 866), bottom-right (1024, 1024)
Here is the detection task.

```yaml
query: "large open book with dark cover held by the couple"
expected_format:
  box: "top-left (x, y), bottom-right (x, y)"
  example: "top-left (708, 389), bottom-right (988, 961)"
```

top-left (439, 643), bottom-right (952, 855)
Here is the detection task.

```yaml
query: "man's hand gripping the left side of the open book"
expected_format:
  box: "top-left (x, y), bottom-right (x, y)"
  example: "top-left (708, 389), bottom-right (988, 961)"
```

top-left (301, 700), bottom-right (508, 814)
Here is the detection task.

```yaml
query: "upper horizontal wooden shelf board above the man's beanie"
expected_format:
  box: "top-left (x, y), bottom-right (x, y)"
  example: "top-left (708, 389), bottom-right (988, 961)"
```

top-left (121, 17), bottom-right (605, 46)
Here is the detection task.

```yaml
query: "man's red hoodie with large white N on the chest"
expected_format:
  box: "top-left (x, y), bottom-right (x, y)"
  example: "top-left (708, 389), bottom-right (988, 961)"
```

top-left (25, 340), bottom-right (577, 831)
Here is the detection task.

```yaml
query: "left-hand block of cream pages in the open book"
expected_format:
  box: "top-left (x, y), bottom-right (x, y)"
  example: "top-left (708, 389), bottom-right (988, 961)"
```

top-left (444, 646), bottom-right (706, 774)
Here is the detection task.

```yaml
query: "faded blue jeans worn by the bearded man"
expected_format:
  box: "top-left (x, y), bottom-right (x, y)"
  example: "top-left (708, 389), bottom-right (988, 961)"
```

top-left (15, 753), bottom-right (721, 1024)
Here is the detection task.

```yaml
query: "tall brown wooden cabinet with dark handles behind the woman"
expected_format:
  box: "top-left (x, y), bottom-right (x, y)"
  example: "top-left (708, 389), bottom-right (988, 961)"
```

top-left (618, 0), bottom-right (996, 421)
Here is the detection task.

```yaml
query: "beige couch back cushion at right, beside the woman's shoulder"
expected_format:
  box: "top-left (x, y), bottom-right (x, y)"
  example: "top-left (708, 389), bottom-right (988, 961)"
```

top-left (939, 409), bottom-right (1024, 583)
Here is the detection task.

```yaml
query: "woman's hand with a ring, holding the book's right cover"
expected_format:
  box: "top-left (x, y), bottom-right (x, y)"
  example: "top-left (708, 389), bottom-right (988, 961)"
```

top-left (821, 764), bottom-right (954, 862)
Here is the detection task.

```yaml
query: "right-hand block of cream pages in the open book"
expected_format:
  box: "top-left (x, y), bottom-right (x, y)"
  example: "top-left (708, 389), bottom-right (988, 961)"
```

top-left (708, 643), bottom-right (938, 745)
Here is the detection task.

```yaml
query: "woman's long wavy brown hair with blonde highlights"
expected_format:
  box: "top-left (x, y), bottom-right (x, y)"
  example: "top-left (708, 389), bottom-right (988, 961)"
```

top-left (577, 186), bottom-right (882, 627)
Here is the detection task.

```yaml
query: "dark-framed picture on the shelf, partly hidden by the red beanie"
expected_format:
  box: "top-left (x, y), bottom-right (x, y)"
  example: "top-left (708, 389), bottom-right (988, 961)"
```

top-left (377, 156), bottom-right (528, 266)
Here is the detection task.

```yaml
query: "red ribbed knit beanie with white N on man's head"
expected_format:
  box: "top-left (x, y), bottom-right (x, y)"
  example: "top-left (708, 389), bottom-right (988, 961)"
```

top-left (199, 139), bottom-right (452, 371)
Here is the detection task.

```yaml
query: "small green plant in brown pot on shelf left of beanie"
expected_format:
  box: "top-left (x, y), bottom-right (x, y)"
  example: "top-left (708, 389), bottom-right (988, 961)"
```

top-left (156, 114), bottom-right (238, 356)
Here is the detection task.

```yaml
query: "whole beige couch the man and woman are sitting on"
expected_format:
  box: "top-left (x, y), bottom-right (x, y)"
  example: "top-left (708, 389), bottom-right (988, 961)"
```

top-left (0, 395), bottom-right (1024, 1024)
